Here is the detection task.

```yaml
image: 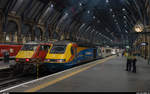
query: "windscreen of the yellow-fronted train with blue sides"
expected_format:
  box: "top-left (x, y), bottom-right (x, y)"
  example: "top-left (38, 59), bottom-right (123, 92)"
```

top-left (50, 45), bottom-right (66, 54)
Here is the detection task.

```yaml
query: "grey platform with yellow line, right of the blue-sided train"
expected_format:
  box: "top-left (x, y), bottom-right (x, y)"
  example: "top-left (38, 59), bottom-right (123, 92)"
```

top-left (0, 56), bottom-right (150, 92)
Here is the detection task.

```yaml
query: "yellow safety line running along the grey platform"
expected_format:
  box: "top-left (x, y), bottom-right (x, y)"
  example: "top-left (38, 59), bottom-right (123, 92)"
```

top-left (24, 57), bottom-right (113, 92)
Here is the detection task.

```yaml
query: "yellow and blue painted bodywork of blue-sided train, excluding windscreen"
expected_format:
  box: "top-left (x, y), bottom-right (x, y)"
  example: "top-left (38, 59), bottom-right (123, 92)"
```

top-left (44, 43), bottom-right (101, 69)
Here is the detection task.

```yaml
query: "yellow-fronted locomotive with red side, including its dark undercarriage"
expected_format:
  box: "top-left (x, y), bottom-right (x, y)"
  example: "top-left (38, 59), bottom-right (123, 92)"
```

top-left (11, 42), bottom-right (51, 74)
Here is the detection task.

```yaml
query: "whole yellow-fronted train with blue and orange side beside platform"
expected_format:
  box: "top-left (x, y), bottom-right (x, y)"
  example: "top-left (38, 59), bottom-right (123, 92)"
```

top-left (44, 41), bottom-right (111, 71)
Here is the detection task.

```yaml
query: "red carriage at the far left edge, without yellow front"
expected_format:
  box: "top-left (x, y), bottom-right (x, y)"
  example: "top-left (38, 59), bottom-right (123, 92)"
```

top-left (0, 44), bottom-right (22, 59)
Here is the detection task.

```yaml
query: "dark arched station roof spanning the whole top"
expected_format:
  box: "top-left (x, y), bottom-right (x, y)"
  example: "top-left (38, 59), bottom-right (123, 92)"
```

top-left (0, 0), bottom-right (150, 47)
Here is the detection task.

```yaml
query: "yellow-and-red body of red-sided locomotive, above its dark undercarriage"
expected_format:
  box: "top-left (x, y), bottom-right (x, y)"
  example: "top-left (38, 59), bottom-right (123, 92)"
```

top-left (16, 42), bottom-right (51, 63)
